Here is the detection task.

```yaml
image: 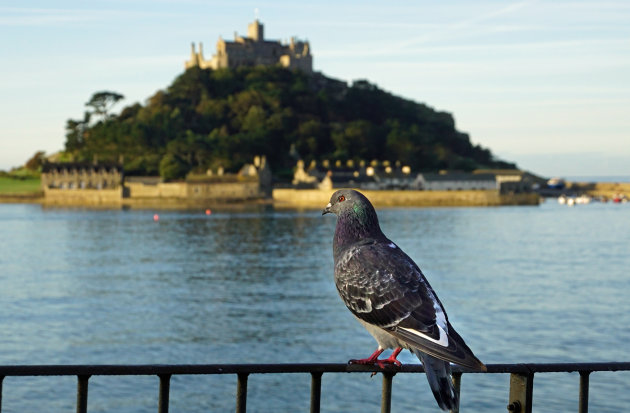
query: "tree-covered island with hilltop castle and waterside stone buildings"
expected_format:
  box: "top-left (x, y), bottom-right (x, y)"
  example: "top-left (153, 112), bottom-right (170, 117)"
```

top-left (0, 19), bottom-right (628, 205)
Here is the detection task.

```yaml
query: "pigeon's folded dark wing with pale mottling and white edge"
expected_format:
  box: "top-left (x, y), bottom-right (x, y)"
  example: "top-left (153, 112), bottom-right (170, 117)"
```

top-left (335, 240), bottom-right (485, 370)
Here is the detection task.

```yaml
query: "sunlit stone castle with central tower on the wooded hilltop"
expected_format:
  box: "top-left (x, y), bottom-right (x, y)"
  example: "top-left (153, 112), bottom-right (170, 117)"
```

top-left (184, 19), bottom-right (313, 73)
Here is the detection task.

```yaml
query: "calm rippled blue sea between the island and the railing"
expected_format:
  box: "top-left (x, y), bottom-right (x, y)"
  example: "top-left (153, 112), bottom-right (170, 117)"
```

top-left (0, 201), bottom-right (630, 413)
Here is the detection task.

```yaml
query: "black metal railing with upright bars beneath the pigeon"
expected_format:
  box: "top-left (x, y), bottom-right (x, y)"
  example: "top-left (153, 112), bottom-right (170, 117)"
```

top-left (0, 362), bottom-right (630, 413)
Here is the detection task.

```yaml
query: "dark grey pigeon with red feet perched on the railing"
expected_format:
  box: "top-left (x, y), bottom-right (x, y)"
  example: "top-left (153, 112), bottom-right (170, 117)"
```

top-left (322, 189), bottom-right (486, 410)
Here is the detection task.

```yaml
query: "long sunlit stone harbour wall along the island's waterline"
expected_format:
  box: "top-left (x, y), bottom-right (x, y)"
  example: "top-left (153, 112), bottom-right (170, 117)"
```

top-left (43, 187), bottom-right (540, 208)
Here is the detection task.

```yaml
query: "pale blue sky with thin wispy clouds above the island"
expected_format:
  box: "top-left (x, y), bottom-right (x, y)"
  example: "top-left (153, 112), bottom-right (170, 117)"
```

top-left (0, 0), bottom-right (630, 177)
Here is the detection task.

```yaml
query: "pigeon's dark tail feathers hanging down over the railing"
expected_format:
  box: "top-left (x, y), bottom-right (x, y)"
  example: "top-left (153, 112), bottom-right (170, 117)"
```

top-left (412, 349), bottom-right (459, 410)
